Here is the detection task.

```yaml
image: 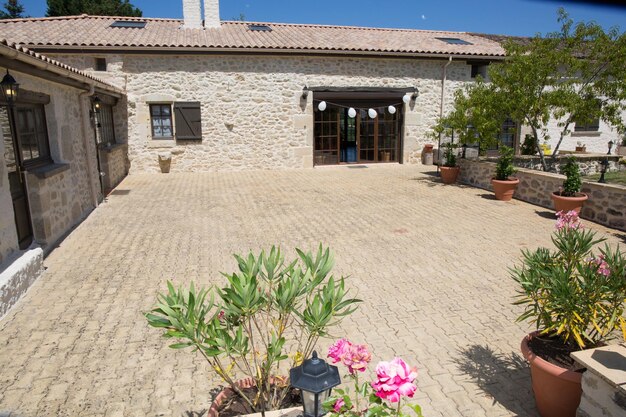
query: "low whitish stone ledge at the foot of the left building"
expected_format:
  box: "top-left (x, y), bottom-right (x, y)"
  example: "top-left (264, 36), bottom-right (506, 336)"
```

top-left (0, 248), bottom-right (43, 318)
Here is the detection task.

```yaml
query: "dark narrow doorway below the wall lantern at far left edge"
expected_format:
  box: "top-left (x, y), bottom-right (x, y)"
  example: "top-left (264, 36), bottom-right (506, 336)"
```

top-left (0, 106), bottom-right (33, 250)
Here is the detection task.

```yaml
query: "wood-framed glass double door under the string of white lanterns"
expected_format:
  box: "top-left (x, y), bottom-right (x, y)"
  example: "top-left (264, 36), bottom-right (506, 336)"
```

top-left (314, 106), bottom-right (401, 165)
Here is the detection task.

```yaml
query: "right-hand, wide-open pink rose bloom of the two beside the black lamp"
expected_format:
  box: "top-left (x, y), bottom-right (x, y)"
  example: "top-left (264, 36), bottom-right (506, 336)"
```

top-left (372, 358), bottom-right (417, 403)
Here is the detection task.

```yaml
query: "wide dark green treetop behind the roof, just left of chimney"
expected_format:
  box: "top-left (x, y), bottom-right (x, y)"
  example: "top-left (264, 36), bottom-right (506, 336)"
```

top-left (46, 0), bottom-right (143, 17)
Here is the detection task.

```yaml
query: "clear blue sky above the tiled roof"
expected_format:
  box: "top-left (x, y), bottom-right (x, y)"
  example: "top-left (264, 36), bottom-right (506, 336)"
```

top-left (17, 0), bottom-right (626, 36)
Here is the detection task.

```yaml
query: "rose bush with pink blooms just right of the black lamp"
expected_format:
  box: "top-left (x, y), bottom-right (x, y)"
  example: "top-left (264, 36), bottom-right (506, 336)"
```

top-left (322, 339), bottom-right (422, 417)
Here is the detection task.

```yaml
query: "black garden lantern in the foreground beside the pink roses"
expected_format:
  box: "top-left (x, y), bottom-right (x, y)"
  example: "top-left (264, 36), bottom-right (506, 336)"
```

top-left (289, 351), bottom-right (341, 417)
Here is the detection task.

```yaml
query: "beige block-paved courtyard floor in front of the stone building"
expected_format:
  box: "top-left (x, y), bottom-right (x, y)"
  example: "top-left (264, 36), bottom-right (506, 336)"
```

top-left (0, 165), bottom-right (624, 417)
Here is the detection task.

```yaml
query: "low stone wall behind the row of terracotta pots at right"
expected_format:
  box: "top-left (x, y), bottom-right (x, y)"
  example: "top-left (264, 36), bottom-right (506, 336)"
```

top-left (459, 159), bottom-right (626, 230)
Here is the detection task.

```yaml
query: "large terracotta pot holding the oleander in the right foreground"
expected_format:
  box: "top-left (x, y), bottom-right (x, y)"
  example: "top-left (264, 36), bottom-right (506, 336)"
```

top-left (521, 332), bottom-right (583, 417)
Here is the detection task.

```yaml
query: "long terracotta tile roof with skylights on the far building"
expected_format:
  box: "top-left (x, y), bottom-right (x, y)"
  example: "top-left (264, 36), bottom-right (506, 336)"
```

top-left (0, 15), bottom-right (504, 56)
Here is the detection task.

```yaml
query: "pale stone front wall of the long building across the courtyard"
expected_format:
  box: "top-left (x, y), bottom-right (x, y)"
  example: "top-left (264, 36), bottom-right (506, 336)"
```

top-left (50, 55), bottom-right (471, 173)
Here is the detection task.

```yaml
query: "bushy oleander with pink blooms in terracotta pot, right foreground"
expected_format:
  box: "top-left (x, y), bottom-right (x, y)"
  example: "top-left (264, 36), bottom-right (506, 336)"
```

top-left (511, 211), bottom-right (626, 417)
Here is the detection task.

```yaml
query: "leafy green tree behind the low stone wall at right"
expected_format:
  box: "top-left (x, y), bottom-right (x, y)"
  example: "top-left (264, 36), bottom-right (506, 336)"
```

top-left (432, 9), bottom-right (626, 171)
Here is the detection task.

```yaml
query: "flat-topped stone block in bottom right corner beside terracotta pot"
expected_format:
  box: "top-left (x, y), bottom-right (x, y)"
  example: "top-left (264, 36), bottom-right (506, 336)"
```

top-left (572, 344), bottom-right (626, 417)
